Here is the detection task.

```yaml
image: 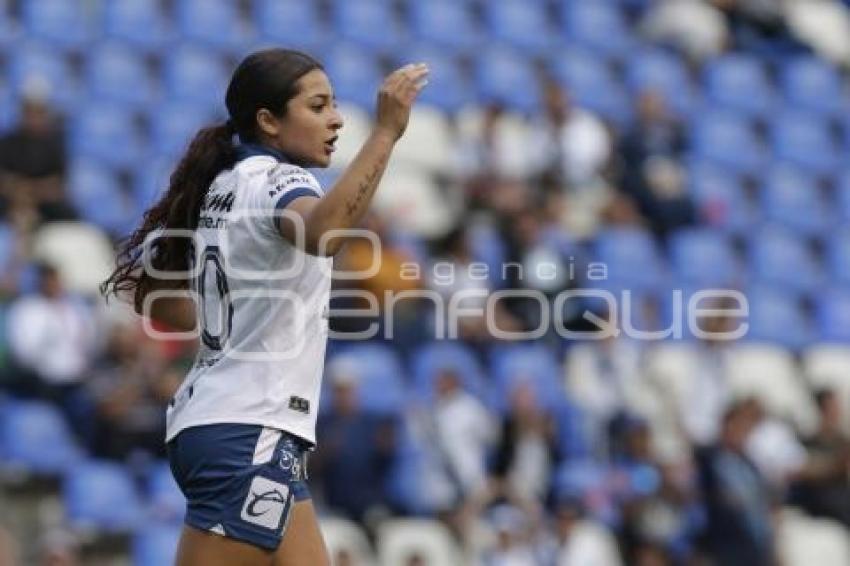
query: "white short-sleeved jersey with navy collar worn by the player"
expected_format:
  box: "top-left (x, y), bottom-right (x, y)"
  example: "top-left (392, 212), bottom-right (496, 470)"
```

top-left (166, 146), bottom-right (333, 443)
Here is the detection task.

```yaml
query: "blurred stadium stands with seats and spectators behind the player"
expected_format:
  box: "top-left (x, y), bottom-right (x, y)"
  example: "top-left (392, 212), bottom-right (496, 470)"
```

top-left (0, 0), bottom-right (850, 566)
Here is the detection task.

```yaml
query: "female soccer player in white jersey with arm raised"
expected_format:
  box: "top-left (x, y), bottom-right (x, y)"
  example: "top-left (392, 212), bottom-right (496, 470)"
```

top-left (103, 49), bottom-right (428, 566)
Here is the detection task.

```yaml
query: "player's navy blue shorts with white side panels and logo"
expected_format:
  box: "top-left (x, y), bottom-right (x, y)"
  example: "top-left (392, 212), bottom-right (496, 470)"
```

top-left (168, 424), bottom-right (311, 550)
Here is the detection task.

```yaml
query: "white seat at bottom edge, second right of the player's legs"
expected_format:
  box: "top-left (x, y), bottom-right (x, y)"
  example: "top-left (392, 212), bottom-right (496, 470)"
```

top-left (377, 519), bottom-right (463, 565)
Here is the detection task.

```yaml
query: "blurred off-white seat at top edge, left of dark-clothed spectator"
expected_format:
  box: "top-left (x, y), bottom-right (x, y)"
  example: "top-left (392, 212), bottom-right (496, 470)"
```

top-left (640, 0), bottom-right (729, 61)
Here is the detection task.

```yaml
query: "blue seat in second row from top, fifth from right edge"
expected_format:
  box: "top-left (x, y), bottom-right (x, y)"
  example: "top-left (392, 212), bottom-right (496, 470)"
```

top-left (475, 48), bottom-right (540, 113)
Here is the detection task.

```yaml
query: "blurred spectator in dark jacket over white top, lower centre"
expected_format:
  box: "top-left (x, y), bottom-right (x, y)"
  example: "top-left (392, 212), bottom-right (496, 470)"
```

top-left (493, 381), bottom-right (558, 512)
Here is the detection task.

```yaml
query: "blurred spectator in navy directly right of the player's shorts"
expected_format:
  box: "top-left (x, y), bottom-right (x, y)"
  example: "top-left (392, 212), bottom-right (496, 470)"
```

top-left (310, 360), bottom-right (396, 522)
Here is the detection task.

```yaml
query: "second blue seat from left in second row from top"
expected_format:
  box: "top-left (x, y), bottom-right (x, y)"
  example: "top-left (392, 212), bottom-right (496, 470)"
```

top-left (86, 43), bottom-right (156, 108)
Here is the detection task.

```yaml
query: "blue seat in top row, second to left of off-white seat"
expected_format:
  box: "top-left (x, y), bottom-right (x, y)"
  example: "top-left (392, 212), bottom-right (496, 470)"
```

top-left (484, 0), bottom-right (557, 55)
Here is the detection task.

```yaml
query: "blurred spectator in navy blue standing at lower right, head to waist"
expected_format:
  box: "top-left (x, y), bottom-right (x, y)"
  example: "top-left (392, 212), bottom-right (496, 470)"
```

top-left (698, 403), bottom-right (776, 566)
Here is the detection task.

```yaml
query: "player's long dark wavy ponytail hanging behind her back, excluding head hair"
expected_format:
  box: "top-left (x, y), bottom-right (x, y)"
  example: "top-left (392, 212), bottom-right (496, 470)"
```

top-left (100, 120), bottom-right (236, 311)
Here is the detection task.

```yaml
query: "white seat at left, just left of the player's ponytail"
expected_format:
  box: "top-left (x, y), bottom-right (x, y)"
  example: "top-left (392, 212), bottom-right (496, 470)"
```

top-left (32, 221), bottom-right (116, 297)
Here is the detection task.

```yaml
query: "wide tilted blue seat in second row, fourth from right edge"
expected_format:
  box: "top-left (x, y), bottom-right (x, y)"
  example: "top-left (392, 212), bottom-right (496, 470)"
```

top-left (552, 48), bottom-right (632, 125)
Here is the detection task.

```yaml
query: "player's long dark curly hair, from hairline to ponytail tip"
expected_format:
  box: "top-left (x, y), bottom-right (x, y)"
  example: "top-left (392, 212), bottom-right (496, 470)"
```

top-left (100, 49), bottom-right (323, 311)
